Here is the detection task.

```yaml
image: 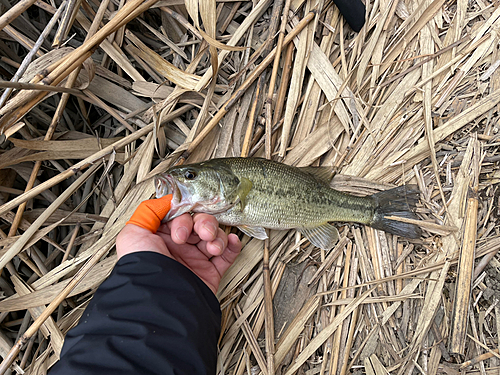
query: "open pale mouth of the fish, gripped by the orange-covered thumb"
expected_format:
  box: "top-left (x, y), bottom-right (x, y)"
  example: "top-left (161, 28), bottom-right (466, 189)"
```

top-left (155, 175), bottom-right (194, 223)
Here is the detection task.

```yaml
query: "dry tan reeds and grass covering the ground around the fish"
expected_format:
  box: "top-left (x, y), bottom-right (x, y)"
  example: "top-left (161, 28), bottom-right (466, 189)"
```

top-left (0, 0), bottom-right (500, 375)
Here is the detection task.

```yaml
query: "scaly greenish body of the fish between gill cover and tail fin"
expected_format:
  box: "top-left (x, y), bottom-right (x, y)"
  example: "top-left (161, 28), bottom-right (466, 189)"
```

top-left (211, 158), bottom-right (375, 229)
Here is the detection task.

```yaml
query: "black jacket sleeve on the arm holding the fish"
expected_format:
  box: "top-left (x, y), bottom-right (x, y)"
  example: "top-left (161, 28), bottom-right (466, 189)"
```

top-left (49, 252), bottom-right (221, 375)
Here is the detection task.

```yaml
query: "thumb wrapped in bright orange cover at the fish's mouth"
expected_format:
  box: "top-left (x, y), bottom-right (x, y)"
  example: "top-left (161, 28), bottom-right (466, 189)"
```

top-left (127, 194), bottom-right (172, 233)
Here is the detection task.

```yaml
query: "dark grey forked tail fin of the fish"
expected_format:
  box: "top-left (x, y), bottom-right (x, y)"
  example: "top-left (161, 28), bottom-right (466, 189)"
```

top-left (370, 185), bottom-right (422, 238)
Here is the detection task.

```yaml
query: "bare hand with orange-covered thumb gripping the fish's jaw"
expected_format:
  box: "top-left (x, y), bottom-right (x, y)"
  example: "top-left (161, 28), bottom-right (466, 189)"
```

top-left (116, 195), bottom-right (241, 294)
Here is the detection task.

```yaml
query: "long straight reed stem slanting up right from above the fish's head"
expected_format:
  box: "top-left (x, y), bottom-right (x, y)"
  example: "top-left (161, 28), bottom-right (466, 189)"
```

top-left (176, 10), bottom-right (317, 164)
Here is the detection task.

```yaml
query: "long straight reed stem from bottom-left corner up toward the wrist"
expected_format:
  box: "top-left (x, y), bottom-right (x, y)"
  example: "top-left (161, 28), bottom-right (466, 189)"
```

top-left (0, 243), bottom-right (113, 375)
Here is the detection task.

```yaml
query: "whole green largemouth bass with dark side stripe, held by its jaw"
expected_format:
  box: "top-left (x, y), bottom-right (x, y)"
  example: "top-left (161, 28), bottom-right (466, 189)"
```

top-left (154, 157), bottom-right (421, 250)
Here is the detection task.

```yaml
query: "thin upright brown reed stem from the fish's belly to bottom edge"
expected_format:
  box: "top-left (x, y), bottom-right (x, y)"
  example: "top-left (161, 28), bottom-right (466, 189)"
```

top-left (262, 236), bottom-right (276, 375)
